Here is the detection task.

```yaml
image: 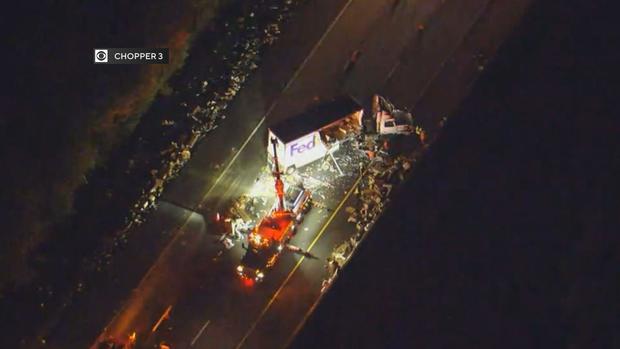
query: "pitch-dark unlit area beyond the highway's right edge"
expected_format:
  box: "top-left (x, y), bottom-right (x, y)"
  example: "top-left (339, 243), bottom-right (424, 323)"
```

top-left (293, 1), bottom-right (620, 348)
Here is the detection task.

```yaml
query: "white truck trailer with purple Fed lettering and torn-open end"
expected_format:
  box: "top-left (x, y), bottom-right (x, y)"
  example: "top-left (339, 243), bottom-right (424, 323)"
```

top-left (267, 96), bottom-right (363, 172)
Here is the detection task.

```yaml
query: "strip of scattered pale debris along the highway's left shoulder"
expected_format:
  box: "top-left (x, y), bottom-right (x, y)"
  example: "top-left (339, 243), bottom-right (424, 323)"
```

top-left (120, 0), bottom-right (300, 232)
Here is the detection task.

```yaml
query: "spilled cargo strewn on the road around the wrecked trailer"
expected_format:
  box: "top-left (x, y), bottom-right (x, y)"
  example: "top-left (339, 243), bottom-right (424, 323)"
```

top-left (213, 98), bottom-right (426, 291)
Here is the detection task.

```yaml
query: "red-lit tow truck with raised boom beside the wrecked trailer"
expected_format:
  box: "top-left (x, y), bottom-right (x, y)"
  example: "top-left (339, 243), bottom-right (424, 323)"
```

top-left (237, 138), bottom-right (311, 282)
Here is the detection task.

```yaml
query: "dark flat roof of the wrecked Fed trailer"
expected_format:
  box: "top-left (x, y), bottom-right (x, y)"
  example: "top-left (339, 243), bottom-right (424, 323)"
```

top-left (269, 96), bottom-right (362, 143)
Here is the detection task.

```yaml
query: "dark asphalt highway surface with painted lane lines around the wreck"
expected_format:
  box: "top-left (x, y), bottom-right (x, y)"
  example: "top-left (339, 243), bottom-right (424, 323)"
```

top-left (31, 0), bottom-right (528, 348)
